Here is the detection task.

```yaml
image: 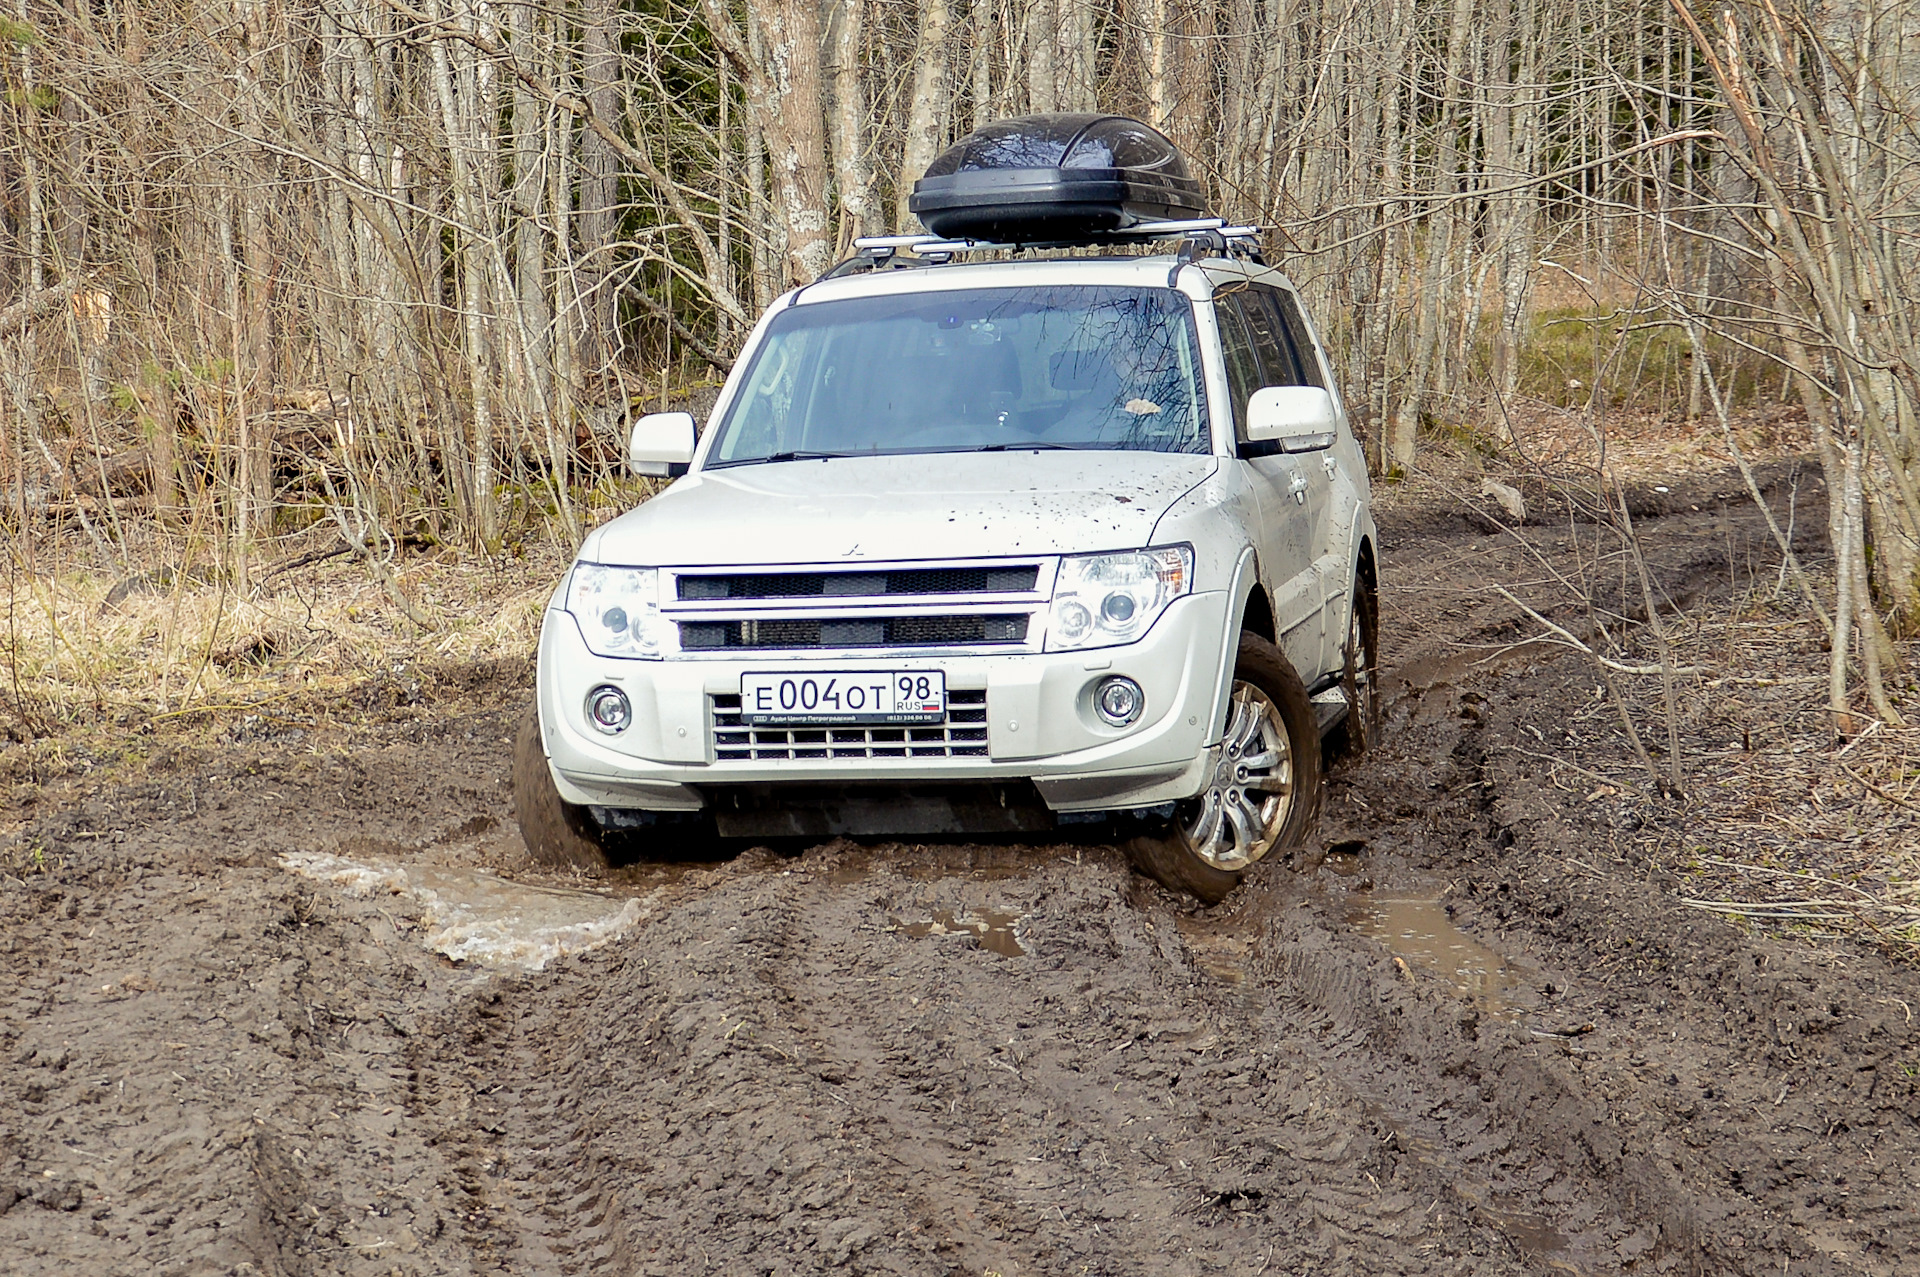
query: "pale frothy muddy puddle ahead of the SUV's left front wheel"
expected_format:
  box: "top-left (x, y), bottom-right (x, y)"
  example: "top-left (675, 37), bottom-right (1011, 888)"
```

top-left (280, 851), bottom-right (647, 972)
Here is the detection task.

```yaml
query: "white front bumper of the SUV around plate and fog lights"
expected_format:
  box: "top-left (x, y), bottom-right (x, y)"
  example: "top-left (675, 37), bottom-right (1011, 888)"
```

top-left (540, 591), bottom-right (1233, 812)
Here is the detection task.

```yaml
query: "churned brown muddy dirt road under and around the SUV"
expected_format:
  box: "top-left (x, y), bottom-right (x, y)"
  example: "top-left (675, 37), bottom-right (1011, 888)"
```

top-left (0, 462), bottom-right (1920, 1277)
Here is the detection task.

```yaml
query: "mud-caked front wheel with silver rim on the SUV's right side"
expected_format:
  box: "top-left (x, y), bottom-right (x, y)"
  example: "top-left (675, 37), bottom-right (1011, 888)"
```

top-left (1127, 634), bottom-right (1321, 904)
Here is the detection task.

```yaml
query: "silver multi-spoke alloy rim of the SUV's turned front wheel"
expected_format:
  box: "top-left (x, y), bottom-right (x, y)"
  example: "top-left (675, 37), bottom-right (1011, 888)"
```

top-left (1181, 680), bottom-right (1294, 872)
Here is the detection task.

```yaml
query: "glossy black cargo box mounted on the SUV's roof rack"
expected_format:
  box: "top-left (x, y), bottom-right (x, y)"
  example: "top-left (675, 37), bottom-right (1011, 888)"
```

top-left (906, 113), bottom-right (1206, 244)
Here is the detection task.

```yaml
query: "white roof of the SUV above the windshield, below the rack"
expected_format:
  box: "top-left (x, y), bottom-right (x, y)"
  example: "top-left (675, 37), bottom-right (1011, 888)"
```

top-left (776, 253), bottom-right (1284, 305)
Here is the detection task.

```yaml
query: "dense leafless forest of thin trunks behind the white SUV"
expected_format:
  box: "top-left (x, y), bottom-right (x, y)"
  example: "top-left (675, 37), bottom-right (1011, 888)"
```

top-left (0, 0), bottom-right (1920, 726)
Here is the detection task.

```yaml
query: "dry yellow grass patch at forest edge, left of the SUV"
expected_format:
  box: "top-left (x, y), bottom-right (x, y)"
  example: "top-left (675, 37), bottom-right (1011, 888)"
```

top-left (0, 514), bottom-right (570, 837)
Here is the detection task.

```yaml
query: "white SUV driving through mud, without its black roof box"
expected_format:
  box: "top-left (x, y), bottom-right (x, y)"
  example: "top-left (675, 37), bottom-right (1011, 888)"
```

top-left (515, 126), bottom-right (1377, 901)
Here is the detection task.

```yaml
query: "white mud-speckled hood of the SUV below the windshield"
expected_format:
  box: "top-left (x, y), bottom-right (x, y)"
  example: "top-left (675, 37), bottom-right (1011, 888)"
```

top-left (580, 451), bottom-right (1219, 566)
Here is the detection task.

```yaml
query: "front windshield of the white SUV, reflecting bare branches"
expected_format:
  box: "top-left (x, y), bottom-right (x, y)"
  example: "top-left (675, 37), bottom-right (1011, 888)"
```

top-left (707, 286), bottom-right (1210, 467)
